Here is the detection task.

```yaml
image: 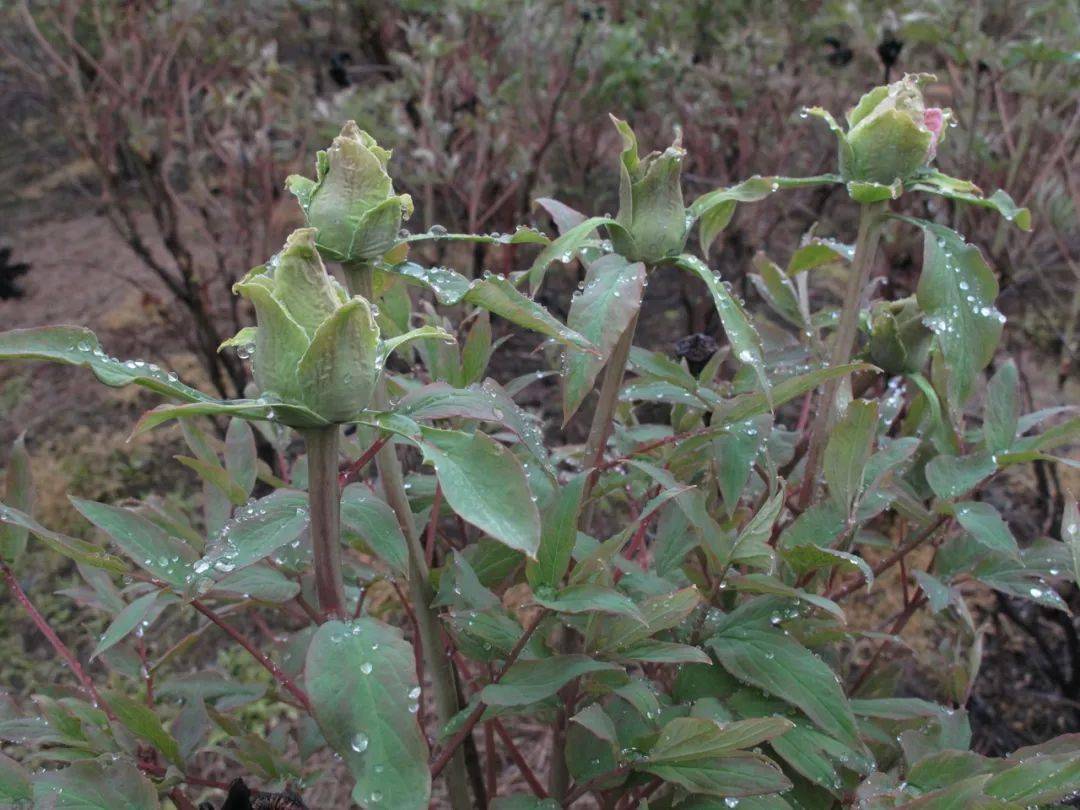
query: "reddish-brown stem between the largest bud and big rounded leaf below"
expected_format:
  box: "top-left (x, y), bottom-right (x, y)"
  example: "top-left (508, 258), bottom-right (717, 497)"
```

top-left (302, 424), bottom-right (345, 619)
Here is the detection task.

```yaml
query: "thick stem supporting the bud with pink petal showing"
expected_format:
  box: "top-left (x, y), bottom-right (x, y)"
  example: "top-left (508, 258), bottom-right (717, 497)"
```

top-left (799, 202), bottom-right (886, 509)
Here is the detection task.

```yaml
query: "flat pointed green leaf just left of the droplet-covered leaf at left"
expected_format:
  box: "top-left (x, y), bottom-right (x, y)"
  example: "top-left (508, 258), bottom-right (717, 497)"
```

top-left (70, 498), bottom-right (199, 588)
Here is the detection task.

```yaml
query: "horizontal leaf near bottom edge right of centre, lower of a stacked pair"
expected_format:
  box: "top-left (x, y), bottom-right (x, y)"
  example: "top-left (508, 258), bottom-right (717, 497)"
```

top-left (635, 754), bottom-right (792, 798)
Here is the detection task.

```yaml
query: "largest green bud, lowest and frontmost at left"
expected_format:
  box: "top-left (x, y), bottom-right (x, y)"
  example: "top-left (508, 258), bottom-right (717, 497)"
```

top-left (228, 228), bottom-right (381, 422)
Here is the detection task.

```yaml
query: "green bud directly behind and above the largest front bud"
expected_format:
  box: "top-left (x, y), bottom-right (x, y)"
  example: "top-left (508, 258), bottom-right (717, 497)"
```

top-left (285, 121), bottom-right (413, 261)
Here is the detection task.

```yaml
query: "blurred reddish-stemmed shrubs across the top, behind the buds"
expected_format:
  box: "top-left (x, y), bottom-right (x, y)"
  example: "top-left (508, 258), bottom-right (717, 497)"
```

top-left (0, 0), bottom-right (1080, 391)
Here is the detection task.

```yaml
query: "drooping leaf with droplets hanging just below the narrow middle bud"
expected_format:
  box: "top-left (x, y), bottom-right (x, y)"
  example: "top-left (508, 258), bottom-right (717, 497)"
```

top-left (563, 254), bottom-right (645, 424)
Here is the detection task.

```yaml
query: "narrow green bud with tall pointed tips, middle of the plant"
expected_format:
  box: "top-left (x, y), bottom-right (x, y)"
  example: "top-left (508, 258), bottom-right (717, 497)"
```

top-left (611, 117), bottom-right (689, 265)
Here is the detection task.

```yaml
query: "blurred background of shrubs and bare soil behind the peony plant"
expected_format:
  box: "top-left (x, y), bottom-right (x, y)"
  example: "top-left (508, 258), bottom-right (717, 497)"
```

top-left (0, 0), bottom-right (1080, 768)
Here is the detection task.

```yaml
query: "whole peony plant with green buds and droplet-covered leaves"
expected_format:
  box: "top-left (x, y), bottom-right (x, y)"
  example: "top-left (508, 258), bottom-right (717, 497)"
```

top-left (0, 77), bottom-right (1080, 810)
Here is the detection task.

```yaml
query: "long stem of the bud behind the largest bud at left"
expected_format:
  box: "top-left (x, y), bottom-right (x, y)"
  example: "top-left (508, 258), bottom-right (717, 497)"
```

top-left (345, 264), bottom-right (472, 810)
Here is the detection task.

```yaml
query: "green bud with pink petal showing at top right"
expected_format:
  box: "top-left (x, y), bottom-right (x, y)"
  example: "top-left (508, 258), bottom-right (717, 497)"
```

top-left (807, 73), bottom-right (951, 186)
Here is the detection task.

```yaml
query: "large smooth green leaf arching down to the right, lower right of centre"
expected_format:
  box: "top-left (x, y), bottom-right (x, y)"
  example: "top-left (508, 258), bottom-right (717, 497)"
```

top-left (707, 623), bottom-right (863, 751)
